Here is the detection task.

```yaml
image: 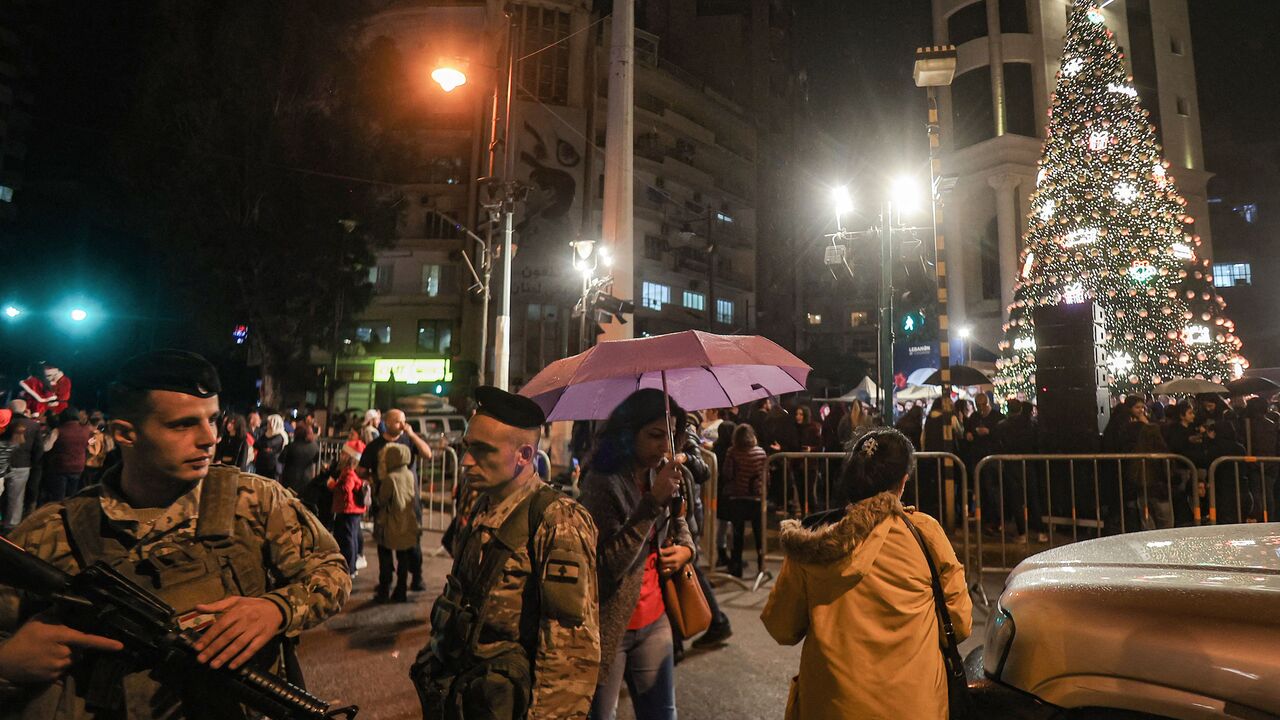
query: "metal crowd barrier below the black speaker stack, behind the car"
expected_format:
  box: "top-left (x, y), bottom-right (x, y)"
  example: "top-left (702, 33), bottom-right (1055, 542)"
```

top-left (966, 454), bottom-right (1203, 578)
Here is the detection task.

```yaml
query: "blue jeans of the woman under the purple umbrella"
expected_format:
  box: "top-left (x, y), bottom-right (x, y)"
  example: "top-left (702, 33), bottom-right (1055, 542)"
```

top-left (588, 614), bottom-right (676, 720)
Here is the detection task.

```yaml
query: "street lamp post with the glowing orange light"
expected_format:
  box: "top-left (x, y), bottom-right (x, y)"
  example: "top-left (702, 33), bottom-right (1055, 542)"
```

top-left (431, 12), bottom-right (522, 389)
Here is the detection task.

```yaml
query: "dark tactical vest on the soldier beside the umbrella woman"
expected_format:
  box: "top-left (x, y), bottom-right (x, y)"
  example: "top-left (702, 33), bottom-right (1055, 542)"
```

top-left (410, 486), bottom-right (563, 720)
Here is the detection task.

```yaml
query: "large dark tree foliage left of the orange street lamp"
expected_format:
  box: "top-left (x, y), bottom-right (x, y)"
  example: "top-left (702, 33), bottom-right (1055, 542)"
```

top-left (119, 0), bottom-right (408, 405)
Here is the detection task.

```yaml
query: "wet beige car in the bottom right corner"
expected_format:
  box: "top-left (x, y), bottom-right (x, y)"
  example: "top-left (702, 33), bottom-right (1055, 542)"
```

top-left (966, 523), bottom-right (1280, 720)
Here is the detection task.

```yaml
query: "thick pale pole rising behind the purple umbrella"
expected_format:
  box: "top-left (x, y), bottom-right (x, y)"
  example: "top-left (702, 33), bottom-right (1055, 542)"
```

top-left (602, 0), bottom-right (635, 340)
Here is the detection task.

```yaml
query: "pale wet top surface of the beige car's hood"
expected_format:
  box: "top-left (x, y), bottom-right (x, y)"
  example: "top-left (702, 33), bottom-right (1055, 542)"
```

top-left (1015, 523), bottom-right (1280, 575)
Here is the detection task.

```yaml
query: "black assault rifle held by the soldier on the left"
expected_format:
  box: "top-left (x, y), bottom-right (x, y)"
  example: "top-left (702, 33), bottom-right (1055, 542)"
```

top-left (0, 538), bottom-right (358, 720)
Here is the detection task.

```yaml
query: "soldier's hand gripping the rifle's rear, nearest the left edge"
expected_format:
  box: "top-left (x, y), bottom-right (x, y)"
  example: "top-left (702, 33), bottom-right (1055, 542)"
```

top-left (0, 614), bottom-right (124, 684)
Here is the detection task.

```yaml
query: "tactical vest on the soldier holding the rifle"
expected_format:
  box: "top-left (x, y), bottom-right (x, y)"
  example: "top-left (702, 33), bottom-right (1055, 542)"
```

top-left (23, 465), bottom-right (272, 720)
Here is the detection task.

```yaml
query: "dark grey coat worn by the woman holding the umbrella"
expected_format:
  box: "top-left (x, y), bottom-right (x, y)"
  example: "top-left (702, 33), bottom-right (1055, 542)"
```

top-left (579, 473), bottom-right (698, 680)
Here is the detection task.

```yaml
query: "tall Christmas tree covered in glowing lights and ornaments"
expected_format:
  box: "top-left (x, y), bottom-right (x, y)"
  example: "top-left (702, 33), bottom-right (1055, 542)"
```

top-left (996, 0), bottom-right (1247, 397)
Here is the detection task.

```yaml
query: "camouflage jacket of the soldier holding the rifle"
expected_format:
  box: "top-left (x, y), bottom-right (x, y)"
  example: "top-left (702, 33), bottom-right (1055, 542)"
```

top-left (0, 469), bottom-right (351, 705)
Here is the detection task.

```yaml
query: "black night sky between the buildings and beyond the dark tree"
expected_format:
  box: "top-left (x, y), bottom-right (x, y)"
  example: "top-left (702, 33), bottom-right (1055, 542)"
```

top-left (0, 0), bottom-right (1280, 404)
